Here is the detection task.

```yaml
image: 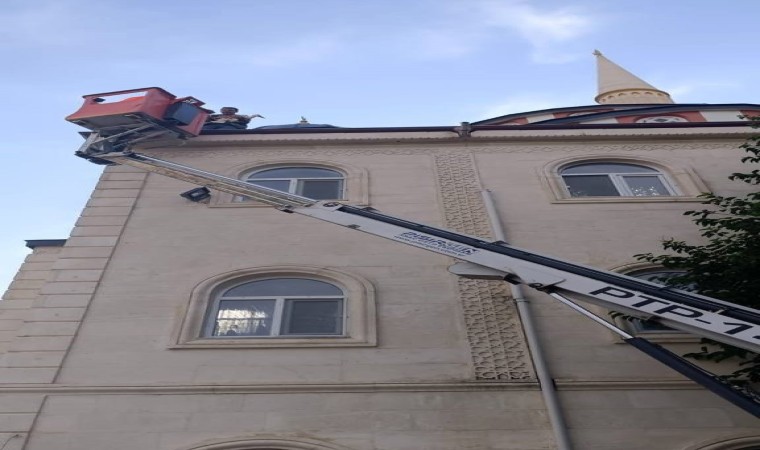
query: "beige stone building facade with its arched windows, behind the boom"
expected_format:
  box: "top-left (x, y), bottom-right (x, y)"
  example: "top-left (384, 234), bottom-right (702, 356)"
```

top-left (0, 55), bottom-right (760, 450)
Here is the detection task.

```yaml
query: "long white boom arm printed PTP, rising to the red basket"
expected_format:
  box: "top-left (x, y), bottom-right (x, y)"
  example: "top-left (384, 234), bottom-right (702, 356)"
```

top-left (91, 152), bottom-right (760, 353)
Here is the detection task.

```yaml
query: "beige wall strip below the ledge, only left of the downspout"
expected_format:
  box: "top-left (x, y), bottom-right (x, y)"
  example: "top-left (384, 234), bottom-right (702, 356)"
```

top-left (22, 391), bottom-right (551, 450)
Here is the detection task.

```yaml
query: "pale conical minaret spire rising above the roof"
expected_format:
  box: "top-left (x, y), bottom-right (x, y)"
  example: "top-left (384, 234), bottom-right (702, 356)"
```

top-left (594, 50), bottom-right (673, 104)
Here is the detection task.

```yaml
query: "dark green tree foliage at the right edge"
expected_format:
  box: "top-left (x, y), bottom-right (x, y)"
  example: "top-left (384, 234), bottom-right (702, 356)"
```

top-left (636, 117), bottom-right (760, 382)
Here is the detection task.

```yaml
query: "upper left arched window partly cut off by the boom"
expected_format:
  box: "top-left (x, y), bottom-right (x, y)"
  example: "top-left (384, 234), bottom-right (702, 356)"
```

top-left (245, 167), bottom-right (345, 200)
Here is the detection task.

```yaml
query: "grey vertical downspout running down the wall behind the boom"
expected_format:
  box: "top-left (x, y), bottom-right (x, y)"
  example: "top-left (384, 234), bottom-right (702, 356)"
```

top-left (481, 189), bottom-right (573, 450)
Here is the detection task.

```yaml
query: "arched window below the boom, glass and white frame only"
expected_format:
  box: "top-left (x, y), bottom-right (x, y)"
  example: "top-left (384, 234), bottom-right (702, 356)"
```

top-left (204, 278), bottom-right (345, 338)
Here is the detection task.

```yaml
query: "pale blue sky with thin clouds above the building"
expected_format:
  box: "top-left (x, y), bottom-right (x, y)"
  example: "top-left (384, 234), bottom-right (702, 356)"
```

top-left (0, 0), bottom-right (760, 291)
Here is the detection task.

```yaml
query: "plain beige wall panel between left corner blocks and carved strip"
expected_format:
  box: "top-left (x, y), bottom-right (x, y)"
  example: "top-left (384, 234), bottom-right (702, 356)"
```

top-left (59, 148), bottom-right (492, 384)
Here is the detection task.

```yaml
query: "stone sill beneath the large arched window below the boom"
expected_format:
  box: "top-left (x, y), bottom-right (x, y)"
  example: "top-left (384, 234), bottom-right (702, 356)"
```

top-left (169, 336), bottom-right (377, 350)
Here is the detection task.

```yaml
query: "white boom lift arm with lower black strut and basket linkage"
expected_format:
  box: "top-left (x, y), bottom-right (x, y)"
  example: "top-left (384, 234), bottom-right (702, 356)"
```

top-left (67, 91), bottom-right (760, 417)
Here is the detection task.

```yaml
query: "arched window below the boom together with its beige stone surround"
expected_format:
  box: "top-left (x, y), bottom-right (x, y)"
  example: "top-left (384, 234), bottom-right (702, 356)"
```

top-left (170, 265), bottom-right (377, 349)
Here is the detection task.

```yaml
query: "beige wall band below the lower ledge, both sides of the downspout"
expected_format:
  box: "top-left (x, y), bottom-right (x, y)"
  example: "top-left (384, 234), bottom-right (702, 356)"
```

top-left (16, 388), bottom-right (757, 450)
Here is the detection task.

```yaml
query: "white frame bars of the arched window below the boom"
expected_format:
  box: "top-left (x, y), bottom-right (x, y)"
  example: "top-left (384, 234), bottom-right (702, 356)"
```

top-left (204, 288), bottom-right (346, 339)
